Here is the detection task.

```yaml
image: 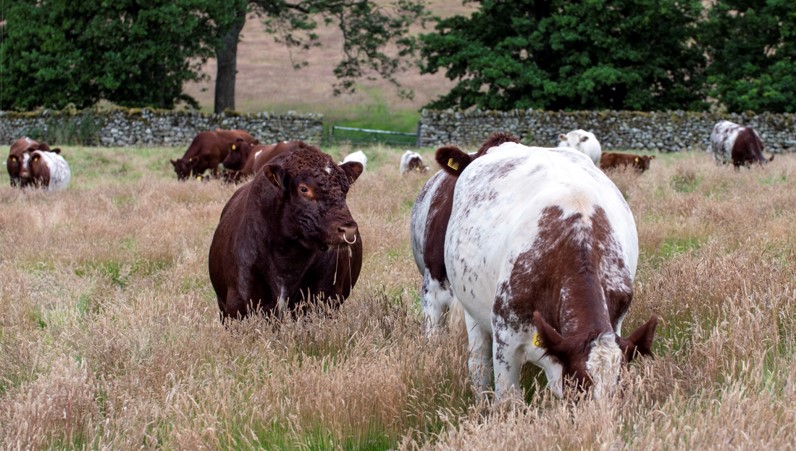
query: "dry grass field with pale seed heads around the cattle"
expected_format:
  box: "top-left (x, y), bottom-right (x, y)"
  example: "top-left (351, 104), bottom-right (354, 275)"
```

top-left (0, 147), bottom-right (796, 450)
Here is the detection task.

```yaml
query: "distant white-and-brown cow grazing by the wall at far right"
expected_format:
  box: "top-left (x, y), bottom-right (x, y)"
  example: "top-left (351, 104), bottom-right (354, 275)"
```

top-left (710, 121), bottom-right (774, 170)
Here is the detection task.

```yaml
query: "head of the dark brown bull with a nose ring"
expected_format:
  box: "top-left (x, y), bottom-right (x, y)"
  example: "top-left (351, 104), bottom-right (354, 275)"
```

top-left (258, 146), bottom-right (363, 251)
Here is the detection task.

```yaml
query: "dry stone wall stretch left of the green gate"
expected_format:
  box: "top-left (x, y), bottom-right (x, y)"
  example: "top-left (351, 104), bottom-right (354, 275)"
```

top-left (0, 109), bottom-right (323, 147)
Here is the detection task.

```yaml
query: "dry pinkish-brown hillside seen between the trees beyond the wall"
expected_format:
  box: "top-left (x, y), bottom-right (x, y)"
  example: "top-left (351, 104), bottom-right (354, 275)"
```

top-left (186, 0), bottom-right (473, 117)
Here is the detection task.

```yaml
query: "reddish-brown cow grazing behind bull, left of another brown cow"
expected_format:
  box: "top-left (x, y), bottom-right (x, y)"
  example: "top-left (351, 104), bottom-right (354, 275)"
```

top-left (171, 130), bottom-right (259, 180)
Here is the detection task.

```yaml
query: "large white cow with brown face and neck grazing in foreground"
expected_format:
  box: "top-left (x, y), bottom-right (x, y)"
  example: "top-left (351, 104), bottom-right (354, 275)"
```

top-left (436, 142), bottom-right (657, 399)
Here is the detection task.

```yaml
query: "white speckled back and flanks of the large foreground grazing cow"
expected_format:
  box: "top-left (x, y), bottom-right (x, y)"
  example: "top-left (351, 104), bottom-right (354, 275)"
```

top-left (445, 144), bottom-right (638, 330)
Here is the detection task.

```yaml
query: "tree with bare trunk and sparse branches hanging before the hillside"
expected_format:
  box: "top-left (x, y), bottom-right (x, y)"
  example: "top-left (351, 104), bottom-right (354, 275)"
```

top-left (208, 0), bottom-right (426, 113)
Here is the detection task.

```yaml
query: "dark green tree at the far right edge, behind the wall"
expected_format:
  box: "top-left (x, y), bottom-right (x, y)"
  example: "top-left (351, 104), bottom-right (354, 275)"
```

top-left (700, 0), bottom-right (796, 113)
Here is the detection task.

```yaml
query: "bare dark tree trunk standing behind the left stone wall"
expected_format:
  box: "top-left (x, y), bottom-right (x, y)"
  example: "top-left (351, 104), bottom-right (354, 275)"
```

top-left (213, 10), bottom-right (246, 113)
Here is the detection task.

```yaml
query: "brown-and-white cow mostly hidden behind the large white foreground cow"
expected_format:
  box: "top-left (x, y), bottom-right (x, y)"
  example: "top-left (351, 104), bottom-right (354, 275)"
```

top-left (409, 133), bottom-right (519, 337)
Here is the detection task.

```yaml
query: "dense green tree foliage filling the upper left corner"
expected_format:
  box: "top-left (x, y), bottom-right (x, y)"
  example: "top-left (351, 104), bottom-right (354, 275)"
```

top-left (0, 0), bottom-right (215, 109)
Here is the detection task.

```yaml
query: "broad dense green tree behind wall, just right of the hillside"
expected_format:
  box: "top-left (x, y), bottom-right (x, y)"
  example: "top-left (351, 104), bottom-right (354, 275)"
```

top-left (421, 0), bottom-right (706, 111)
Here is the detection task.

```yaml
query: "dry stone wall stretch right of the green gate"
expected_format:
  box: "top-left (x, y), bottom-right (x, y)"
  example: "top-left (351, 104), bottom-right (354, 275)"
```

top-left (418, 110), bottom-right (796, 153)
